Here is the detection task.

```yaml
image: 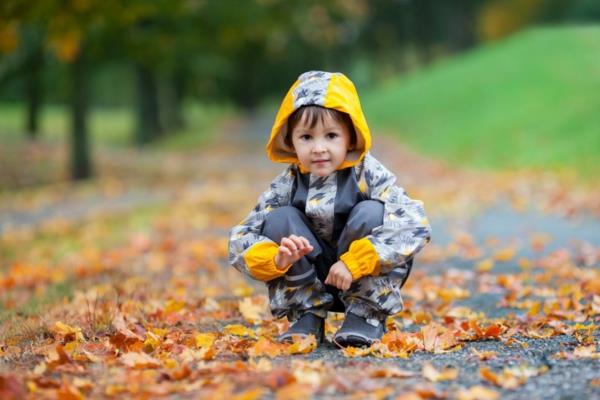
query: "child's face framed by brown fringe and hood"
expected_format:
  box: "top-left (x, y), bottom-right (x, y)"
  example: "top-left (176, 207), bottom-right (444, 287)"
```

top-left (292, 111), bottom-right (351, 176)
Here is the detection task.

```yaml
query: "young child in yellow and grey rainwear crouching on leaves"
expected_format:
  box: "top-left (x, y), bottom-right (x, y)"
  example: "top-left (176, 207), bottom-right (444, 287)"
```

top-left (229, 71), bottom-right (430, 346)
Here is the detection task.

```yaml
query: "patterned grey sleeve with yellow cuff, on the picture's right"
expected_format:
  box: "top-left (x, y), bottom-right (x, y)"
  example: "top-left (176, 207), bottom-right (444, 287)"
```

top-left (340, 153), bottom-right (431, 280)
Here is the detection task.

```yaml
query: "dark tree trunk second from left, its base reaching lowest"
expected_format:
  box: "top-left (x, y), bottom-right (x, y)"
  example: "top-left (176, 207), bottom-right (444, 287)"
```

top-left (71, 49), bottom-right (92, 180)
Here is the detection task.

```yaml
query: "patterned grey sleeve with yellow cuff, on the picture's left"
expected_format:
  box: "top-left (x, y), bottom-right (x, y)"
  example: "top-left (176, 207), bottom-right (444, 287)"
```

top-left (229, 165), bottom-right (295, 281)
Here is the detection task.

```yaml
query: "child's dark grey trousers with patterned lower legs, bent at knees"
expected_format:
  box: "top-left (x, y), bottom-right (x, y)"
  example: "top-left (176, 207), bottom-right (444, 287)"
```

top-left (262, 200), bottom-right (412, 322)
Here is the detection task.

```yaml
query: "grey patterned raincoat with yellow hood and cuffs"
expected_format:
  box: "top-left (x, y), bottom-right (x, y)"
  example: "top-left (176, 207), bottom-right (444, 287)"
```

top-left (229, 71), bottom-right (430, 318)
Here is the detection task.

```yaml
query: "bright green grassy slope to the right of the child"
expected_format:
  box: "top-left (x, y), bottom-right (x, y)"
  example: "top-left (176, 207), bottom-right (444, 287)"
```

top-left (363, 26), bottom-right (600, 178)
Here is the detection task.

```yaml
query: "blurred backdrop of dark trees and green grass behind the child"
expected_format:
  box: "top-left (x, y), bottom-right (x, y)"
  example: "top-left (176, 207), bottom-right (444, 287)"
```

top-left (0, 0), bottom-right (600, 189)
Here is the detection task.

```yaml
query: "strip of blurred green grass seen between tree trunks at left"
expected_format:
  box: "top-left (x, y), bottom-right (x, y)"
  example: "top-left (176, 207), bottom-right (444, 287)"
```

top-left (0, 103), bottom-right (231, 150)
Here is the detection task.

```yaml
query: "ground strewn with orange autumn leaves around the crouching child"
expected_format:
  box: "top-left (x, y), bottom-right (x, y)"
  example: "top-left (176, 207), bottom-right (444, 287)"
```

top-left (0, 114), bottom-right (600, 399)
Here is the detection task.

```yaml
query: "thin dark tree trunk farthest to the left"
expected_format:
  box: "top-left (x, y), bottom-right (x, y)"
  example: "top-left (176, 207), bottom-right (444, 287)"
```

top-left (25, 35), bottom-right (44, 140)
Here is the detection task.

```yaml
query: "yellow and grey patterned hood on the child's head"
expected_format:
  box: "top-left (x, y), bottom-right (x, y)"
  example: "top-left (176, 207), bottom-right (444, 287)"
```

top-left (267, 71), bottom-right (371, 169)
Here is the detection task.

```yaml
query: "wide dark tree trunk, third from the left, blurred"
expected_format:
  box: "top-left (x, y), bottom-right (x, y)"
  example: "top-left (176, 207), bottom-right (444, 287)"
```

top-left (136, 63), bottom-right (162, 145)
